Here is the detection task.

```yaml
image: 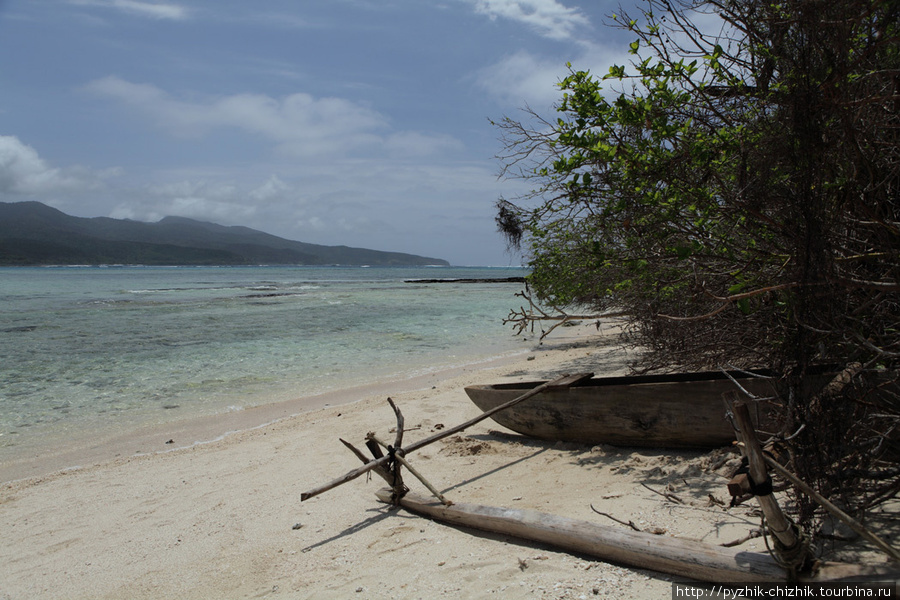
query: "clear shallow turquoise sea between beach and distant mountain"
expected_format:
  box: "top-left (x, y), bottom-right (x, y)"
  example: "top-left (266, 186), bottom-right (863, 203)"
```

top-left (0, 266), bottom-right (526, 462)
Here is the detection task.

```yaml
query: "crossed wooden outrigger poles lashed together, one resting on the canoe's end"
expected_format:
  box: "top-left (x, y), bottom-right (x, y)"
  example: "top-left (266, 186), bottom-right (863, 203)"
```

top-left (300, 373), bottom-right (593, 506)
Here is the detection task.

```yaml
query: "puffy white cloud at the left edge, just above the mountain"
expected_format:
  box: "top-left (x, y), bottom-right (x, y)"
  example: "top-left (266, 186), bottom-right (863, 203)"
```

top-left (0, 135), bottom-right (104, 195)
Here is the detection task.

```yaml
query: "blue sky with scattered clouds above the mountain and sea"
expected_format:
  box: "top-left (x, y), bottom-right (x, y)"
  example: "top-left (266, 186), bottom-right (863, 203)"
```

top-left (0, 0), bottom-right (632, 266)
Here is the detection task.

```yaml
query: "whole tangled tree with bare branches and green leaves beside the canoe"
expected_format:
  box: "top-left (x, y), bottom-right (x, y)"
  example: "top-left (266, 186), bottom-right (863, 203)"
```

top-left (497, 0), bottom-right (900, 536)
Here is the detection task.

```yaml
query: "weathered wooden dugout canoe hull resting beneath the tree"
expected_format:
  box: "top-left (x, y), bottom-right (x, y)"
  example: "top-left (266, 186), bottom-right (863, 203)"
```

top-left (465, 371), bottom-right (788, 448)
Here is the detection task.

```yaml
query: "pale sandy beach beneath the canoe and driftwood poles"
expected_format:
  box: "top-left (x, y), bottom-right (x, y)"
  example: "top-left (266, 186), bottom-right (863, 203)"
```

top-left (0, 327), bottom-right (892, 600)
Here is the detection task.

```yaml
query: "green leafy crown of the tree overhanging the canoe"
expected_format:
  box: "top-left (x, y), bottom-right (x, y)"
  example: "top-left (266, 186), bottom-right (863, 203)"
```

top-left (496, 0), bottom-right (898, 366)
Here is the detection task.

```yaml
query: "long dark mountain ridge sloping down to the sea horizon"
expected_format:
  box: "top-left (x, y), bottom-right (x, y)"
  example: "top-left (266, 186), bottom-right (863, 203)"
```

top-left (0, 202), bottom-right (449, 266)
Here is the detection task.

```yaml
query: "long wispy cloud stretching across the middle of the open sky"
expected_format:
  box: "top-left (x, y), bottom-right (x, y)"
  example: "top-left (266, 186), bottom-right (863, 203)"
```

top-left (85, 76), bottom-right (461, 158)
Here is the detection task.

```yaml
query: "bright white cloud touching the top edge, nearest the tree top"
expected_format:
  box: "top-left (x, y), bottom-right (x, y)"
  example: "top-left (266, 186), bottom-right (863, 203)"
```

top-left (470, 0), bottom-right (590, 40)
